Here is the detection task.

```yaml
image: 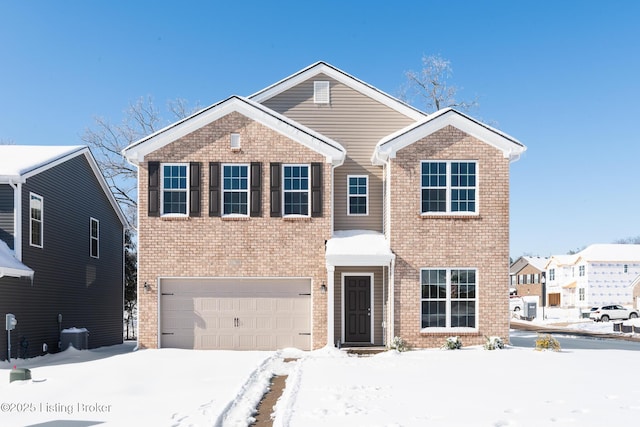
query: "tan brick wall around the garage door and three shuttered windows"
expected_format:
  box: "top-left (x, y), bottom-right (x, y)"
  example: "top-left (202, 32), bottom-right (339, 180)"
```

top-left (138, 113), bottom-right (331, 348)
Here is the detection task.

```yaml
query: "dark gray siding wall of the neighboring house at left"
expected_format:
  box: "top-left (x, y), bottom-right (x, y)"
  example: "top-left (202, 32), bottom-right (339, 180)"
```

top-left (0, 155), bottom-right (124, 359)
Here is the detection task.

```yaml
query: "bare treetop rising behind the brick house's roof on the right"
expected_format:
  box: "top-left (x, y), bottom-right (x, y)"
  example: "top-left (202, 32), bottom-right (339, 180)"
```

top-left (400, 55), bottom-right (478, 113)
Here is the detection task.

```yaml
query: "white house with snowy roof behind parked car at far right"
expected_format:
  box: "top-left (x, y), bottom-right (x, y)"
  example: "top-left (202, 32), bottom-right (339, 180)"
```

top-left (546, 244), bottom-right (640, 308)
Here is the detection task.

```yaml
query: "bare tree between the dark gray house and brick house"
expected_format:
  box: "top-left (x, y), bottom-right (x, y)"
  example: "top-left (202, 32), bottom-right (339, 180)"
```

top-left (81, 97), bottom-right (196, 229)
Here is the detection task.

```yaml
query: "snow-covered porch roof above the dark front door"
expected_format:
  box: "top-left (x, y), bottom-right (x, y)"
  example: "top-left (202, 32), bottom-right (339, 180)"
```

top-left (326, 230), bottom-right (395, 265)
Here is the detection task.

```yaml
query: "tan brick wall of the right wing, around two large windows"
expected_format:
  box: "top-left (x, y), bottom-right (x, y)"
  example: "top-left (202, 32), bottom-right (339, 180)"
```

top-left (390, 126), bottom-right (509, 347)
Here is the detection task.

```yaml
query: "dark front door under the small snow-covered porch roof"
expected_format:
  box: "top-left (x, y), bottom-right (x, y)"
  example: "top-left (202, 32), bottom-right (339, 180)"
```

top-left (344, 276), bottom-right (371, 343)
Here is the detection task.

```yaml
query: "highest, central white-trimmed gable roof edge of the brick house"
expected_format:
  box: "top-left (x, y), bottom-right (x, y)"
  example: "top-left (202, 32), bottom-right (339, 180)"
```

top-left (249, 61), bottom-right (427, 120)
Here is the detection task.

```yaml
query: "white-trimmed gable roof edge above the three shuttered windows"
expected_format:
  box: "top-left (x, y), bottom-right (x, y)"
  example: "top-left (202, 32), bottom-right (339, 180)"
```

top-left (122, 95), bottom-right (346, 165)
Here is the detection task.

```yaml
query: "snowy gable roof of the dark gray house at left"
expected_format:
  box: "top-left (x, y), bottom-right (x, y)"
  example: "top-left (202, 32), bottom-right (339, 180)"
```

top-left (0, 145), bottom-right (127, 225)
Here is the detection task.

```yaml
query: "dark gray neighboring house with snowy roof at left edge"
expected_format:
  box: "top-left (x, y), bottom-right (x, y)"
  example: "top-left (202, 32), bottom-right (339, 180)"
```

top-left (0, 145), bottom-right (125, 359)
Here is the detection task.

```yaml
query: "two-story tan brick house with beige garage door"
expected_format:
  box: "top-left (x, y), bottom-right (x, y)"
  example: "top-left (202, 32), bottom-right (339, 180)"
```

top-left (123, 62), bottom-right (525, 349)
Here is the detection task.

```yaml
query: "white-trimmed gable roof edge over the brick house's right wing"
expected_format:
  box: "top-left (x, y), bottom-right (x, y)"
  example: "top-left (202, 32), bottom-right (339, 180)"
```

top-left (372, 108), bottom-right (527, 164)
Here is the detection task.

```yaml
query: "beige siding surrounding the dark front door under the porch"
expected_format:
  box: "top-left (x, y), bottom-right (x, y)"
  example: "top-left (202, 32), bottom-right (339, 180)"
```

top-left (333, 267), bottom-right (385, 345)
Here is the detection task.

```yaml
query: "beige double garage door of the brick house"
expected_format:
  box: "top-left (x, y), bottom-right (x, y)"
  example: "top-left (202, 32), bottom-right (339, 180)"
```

top-left (160, 279), bottom-right (311, 350)
